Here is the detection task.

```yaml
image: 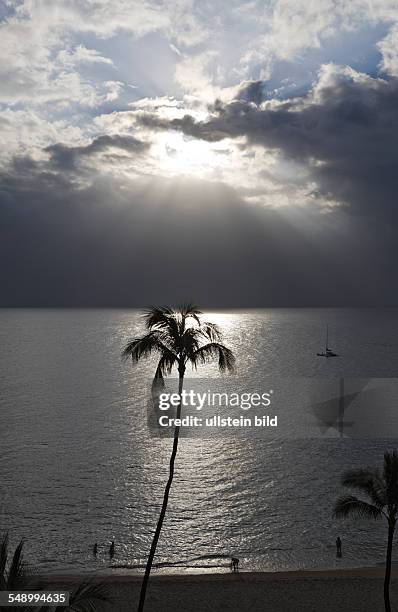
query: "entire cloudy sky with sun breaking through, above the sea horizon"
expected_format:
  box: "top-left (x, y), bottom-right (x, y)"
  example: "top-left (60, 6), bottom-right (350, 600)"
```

top-left (0, 0), bottom-right (398, 308)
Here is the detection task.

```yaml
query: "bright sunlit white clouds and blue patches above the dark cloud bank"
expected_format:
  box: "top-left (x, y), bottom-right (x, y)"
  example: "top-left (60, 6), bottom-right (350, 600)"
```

top-left (0, 0), bottom-right (398, 210)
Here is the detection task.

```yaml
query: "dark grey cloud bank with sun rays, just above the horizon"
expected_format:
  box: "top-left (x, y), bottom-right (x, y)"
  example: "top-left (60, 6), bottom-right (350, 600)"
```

top-left (0, 147), bottom-right (398, 307)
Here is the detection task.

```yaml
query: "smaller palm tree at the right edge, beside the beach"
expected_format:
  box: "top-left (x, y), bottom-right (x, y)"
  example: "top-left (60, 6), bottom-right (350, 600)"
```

top-left (333, 451), bottom-right (398, 612)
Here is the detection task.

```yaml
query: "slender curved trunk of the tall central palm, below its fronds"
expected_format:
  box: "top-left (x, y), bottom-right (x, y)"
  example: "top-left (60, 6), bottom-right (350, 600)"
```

top-left (138, 371), bottom-right (184, 612)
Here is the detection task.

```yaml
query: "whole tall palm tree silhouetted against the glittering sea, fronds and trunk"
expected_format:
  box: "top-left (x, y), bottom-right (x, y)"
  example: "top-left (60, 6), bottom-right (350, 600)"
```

top-left (122, 304), bottom-right (235, 612)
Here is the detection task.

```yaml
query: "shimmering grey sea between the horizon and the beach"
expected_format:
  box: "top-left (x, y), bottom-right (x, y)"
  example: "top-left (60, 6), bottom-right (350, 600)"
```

top-left (0, 309), bottom-right (398, 571)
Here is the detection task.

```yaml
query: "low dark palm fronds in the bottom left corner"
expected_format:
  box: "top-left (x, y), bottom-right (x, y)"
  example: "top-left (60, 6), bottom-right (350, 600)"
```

top-left (0, 533), bottom-right (112, 612)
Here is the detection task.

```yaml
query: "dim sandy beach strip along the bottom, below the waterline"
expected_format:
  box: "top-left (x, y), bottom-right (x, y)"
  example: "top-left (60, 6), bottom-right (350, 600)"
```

top-left (45, 568), bottom-right (398, 612)
